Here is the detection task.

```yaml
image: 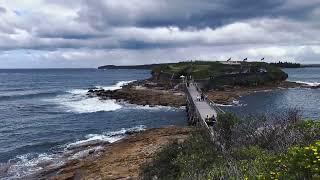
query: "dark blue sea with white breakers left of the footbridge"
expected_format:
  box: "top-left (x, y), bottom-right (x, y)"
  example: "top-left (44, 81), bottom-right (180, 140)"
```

top-left (0, 69), bottom-right (186, 179)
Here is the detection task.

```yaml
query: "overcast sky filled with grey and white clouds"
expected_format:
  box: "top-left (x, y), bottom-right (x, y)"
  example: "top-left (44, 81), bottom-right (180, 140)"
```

top-left (0, 0), bottom-right (320, 68)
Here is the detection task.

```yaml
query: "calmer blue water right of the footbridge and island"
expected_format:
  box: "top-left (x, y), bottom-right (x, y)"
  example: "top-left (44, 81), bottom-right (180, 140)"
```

top-left (224, 68), bottom-right (320, 120)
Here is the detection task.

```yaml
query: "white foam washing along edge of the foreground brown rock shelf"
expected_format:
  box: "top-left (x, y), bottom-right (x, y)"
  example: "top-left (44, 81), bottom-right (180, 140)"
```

top-left (0, 125), bottom-right (146, 180)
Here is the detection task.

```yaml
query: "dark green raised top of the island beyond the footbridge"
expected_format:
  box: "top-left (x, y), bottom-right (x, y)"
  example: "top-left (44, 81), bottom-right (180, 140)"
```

top-left (152, 61), bottom-right (288, 89)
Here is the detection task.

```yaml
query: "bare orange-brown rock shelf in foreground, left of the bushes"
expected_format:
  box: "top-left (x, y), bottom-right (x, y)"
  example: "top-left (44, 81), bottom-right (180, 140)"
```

top-left (37, 126), bottom-right (193, 180)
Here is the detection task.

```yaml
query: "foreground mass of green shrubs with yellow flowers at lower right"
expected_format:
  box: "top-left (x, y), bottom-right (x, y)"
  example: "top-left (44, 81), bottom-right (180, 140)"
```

top-left (141, 110), bottom-right (320, 179)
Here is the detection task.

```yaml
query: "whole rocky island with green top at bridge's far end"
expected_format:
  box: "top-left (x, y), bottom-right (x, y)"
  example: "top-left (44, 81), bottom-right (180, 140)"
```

top-left (88, 61), bottom-right (302, 107)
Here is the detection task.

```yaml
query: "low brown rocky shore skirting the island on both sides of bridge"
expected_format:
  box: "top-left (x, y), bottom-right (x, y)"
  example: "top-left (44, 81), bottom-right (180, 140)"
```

top-left (88, 80), bottom-right (312, 108)
